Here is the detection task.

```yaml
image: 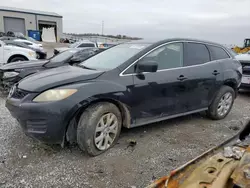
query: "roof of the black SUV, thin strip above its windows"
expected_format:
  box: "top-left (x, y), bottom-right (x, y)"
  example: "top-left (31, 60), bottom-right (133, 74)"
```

top-left (128, 38), bottom-right (222, 46)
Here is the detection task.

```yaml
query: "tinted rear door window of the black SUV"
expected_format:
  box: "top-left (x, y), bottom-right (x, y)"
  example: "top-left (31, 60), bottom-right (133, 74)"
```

top-left (184, 43), bottom-right (210, 66)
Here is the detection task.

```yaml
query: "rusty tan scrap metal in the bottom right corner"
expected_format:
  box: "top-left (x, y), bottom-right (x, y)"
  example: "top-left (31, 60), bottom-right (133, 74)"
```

top-left (148, 122), bottom-right (250, 188)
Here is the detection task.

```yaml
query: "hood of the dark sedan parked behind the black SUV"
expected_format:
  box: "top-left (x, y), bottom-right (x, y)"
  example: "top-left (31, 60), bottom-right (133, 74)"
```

top-left (0, 60), bottom-right (48, 71)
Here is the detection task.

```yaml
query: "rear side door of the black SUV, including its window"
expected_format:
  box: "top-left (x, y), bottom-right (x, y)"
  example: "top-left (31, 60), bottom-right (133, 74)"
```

top-left (184, 42), bottom-right (221, 111)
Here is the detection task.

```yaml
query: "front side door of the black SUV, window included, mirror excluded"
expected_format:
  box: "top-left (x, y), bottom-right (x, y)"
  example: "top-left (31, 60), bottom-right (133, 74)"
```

top-left (128, 43), bottom-right (190, 124)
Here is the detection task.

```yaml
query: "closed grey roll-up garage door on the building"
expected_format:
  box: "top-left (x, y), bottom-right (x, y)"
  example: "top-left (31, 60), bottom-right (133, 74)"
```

top-left (3, 17), bottom-right (26, 35)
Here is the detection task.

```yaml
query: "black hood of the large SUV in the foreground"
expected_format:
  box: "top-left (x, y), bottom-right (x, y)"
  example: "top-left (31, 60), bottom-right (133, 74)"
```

top-left (18, 65), bottom-right (104, 92)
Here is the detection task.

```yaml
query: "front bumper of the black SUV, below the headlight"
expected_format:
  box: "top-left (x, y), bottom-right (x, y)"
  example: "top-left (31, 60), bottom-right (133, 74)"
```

top-left (6, 93), bottom-right (74, 144)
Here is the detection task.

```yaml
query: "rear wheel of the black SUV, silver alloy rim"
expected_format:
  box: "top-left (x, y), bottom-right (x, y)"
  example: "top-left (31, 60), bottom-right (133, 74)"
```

top-left (207, 86), bottom-right (235, 120)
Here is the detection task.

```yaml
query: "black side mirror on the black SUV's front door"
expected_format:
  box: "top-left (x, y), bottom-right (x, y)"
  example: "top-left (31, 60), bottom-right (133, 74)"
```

top-left (136, 60), bottom-right (158, 73)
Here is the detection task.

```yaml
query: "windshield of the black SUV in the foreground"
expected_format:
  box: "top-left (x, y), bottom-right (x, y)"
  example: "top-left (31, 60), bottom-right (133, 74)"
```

top-left (80, 44), bottom-right (149, 70)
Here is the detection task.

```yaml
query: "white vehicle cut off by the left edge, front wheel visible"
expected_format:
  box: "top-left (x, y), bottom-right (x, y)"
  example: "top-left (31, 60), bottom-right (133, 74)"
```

top-left (0, 41), bottom-right (37, 65)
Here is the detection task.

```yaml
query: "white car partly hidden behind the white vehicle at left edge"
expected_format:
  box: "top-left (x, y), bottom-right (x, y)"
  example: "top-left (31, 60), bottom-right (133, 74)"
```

top-left (4, 40), bottom-right (47, 59)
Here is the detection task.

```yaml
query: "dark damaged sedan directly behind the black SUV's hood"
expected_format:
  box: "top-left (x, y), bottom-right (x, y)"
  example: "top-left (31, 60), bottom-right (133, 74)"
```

top-left (0, 48), bottom-right (100, 91)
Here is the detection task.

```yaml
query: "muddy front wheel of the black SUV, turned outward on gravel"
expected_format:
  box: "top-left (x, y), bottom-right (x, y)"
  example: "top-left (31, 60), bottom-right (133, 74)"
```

top-left (77, 102), bottom-right (122, 156)
